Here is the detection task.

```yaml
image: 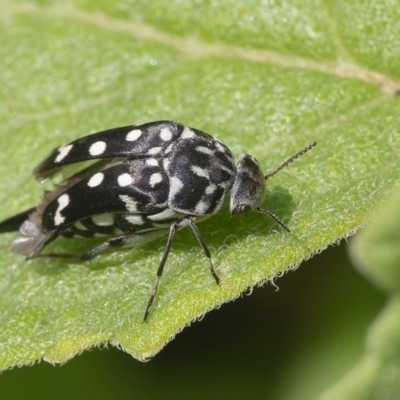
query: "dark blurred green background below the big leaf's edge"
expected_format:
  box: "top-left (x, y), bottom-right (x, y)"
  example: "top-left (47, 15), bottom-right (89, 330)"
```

top-left (0, 242), bottom-right (385, 400)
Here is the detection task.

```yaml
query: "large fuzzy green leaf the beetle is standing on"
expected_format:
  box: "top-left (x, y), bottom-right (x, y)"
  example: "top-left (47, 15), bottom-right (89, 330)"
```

top-left (0, 0), bottom-right (400, 368)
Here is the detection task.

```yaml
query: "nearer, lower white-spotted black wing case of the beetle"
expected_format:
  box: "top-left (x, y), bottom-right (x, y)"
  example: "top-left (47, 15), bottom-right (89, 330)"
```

top-left (39, 158), bottom-right (169, 231)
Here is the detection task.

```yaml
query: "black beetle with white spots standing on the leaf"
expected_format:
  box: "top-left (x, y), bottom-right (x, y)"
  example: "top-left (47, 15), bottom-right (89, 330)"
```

top-left (0, 121), bottom-right (315, 320)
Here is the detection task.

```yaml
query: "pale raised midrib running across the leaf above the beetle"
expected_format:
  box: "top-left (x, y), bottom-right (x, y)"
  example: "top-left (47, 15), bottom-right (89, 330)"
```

top-left (6, 3), bottom-right (400, 95)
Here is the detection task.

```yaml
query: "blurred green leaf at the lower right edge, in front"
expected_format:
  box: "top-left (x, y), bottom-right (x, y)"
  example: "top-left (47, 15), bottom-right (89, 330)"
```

top-left (322, 188), bottom-right (400, 400)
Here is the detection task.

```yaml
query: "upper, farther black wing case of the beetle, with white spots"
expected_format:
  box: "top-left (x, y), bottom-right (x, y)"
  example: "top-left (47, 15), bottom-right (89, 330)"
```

top-left (33, 121), bottom-right (184, 181)
